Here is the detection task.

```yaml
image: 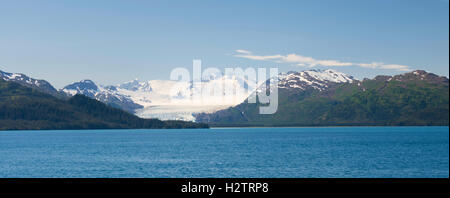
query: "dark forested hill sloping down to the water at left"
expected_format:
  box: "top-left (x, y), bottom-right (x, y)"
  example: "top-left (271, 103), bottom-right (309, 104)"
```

top-left (0, 80), bottom-right (207, 130)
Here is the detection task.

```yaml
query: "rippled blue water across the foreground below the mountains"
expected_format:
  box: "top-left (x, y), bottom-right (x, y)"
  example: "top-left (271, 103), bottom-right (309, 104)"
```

top-left (0, 127), bottom-right (449, 178)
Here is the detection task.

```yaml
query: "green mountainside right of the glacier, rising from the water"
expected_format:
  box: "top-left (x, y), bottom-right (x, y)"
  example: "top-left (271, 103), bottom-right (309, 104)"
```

top-left (196, 70), bottom-right (449, 126)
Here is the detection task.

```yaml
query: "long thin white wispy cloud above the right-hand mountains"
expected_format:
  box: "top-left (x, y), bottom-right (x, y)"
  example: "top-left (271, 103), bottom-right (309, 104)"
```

top-left (233, 49), bottom-right (411, 71)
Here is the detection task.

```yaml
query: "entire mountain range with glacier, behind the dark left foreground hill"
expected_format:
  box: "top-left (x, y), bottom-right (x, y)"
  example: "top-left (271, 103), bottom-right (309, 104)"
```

top-left (0, 69), bottom-right (449, 126)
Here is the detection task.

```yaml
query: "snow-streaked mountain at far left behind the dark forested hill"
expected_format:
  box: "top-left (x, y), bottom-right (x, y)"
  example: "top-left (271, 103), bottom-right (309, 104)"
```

top-left (0, 70), bottom-right (61, 97)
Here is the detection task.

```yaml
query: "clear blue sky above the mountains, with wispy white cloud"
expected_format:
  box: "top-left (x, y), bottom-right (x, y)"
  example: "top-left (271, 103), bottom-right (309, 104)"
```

top-left (0, 0), bottom-right (449, 88)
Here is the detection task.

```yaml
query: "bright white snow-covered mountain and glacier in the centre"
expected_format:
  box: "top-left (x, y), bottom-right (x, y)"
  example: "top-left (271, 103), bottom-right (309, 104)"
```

top-left (61, 73), bottom-right (255, 120)
